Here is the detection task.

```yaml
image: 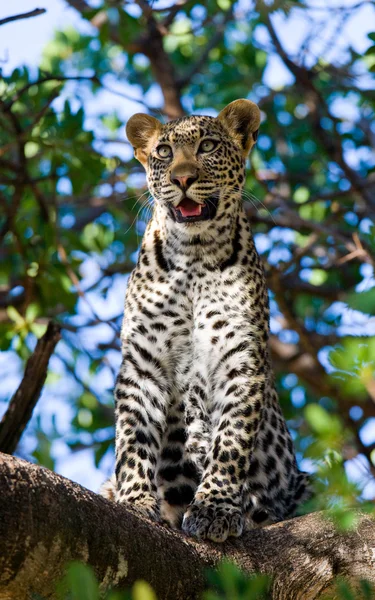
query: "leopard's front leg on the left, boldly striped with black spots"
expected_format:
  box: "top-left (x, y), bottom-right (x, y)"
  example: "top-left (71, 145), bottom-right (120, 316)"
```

top-left (115, 336), bottom-right (168, 521)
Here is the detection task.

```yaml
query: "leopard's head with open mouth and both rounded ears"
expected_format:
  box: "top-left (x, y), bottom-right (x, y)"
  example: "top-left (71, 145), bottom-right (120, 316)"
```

top-left (126, 100), bottom-right (260, 229)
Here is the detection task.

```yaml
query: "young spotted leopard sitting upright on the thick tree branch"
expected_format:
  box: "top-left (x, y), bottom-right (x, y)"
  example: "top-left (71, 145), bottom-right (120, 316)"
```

top-left (101, 99), bottom-right (310, 543)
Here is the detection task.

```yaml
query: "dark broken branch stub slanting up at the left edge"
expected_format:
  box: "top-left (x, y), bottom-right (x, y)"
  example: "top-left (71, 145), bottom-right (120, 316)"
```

top-left (0, 321), bottom-right (61, 454)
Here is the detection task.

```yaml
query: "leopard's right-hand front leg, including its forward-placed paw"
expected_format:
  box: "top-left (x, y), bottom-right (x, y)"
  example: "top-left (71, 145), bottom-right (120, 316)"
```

top-left (182, 341), bottom-right (267, 542)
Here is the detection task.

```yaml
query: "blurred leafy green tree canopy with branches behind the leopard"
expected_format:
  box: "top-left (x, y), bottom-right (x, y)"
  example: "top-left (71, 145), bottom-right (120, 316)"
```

top-left (0, 0), bottom-right (375, 521)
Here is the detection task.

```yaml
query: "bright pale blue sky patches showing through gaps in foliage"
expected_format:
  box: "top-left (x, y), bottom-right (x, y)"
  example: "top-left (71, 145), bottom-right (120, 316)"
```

top-left (0, 0), bottom-right (375, 496)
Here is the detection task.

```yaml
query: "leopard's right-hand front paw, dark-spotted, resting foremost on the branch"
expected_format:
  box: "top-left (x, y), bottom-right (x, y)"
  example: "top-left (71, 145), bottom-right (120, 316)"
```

top-left (182, 502), bottom-right (244, 542)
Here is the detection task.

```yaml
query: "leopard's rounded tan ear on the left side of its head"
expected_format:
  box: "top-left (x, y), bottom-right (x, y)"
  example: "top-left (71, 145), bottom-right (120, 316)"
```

top-left (126, 113), bottom-right (162, 166)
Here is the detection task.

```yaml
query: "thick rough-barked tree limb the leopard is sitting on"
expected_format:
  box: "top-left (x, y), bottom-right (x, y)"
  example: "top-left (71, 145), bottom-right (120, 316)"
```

top-left (0, 455), bottom-right (375, 600)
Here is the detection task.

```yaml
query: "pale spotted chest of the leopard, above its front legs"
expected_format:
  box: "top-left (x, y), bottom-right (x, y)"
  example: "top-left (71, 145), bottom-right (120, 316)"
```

top-left (122, 252), bottom-right (262, 387)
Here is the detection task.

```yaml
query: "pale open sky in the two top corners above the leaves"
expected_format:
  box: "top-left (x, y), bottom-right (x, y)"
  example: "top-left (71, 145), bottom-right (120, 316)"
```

top-left (0, 0), bottom-right (375, 87)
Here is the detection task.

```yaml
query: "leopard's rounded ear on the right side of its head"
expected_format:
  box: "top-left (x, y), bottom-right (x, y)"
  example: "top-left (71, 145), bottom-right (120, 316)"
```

top-left (217, 99), bottom-right (260, 158)
